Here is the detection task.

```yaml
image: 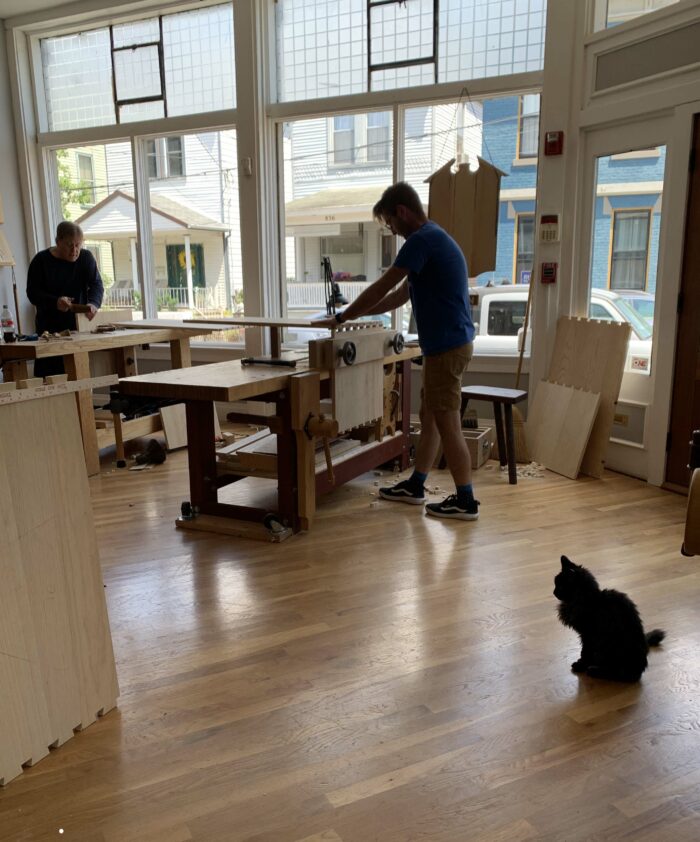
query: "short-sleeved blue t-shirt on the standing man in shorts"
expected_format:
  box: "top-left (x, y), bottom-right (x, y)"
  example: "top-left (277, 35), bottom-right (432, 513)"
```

top-left (394, 220), bottom-right (474, 356)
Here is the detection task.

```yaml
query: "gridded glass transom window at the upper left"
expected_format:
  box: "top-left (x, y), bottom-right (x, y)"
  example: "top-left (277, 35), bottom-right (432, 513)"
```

top-left (41, 3), bottom-right (235, 131)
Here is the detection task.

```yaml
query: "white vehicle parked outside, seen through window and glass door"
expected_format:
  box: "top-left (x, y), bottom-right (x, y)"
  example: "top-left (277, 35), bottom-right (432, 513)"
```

top-left (469, 284), bottom-right (652, 373)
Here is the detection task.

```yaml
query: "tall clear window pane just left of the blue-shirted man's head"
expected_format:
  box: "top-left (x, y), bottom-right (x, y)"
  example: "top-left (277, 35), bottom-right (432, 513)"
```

top-left (283, 106), bottom-right (393, 328)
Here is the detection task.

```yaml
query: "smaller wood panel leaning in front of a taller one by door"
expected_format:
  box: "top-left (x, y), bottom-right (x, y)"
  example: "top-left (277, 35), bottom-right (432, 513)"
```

top-left (525, 380), bottom-right (600, 479)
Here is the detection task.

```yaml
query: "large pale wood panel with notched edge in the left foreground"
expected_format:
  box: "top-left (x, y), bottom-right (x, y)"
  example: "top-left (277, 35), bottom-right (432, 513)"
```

top-left (0, 394), bottom-right (118, 784)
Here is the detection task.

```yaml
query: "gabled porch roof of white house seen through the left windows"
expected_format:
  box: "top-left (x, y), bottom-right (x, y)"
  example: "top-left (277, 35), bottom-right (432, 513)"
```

top-left (76, 190), bottom-right (230, 239)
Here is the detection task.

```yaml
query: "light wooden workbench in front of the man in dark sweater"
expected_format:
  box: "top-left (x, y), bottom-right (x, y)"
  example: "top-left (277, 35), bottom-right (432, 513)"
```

top-left (0, 320), bottom-right (212, 476)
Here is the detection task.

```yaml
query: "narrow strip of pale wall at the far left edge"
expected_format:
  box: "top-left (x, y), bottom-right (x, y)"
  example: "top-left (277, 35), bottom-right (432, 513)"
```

top-left (0, 23), bottom-right (30, 333)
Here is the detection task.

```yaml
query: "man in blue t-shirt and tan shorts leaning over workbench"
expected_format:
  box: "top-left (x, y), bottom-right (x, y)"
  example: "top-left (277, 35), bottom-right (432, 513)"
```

top-left (314, 182), bottom-right (479, 520)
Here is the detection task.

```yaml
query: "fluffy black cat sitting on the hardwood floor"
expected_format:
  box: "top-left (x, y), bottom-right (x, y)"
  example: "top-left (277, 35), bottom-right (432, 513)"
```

top-left (554, 555), bottom-right (666, 681)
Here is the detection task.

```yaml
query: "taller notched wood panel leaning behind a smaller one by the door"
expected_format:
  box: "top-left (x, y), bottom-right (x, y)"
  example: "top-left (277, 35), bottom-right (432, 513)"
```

top-left (547, 316), bottom-right (630, 477)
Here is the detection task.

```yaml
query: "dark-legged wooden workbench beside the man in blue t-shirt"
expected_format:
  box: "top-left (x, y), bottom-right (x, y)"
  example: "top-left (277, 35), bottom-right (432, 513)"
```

top-left (120, 348), bottom-right (420, 534)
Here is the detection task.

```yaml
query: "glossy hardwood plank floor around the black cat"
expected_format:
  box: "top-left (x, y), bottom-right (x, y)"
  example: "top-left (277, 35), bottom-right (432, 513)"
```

top-left (0, 452), bottom-right (700, 842)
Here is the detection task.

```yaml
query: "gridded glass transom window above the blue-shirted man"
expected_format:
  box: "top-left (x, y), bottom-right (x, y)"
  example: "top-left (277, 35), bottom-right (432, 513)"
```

top-left (275, 0), bottom-right (547, 102)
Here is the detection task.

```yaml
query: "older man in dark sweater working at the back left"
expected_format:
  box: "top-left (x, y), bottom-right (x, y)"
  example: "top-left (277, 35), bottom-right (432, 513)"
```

top-left (27, 222), bottom-right (104, 377)
